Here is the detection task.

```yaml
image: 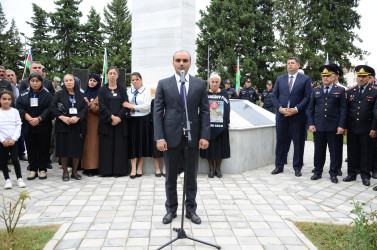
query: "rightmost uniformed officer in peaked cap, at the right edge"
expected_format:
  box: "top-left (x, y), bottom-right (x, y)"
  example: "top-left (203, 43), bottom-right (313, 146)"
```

top-left (343, 65), bottom-right (377, 186)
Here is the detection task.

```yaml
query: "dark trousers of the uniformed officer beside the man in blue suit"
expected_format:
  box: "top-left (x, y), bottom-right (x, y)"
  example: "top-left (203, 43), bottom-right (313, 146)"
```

top-left (314, 131), bottom-right (343, 176)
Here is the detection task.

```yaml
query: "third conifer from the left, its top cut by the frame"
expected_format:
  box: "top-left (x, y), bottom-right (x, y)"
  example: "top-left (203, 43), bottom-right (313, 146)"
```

top-left (50, 0), bottom-right (82, 73)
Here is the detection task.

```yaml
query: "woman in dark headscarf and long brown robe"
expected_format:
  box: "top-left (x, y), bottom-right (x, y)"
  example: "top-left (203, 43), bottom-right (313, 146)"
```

top-left (81, 74), bottom-right (101, 176)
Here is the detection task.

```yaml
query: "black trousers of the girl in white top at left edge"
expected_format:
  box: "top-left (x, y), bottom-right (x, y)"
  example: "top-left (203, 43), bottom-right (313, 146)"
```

top-left (0, 142), bottom-right (22, 180)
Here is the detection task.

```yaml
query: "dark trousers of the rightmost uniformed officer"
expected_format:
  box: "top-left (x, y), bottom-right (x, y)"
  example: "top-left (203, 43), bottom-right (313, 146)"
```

top-left (347, 131), bottom-right (373, 180)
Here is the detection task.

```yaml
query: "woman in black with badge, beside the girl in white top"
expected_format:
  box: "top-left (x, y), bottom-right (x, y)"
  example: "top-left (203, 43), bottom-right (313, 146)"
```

top-left (16, 73), bottom-right (53, 180)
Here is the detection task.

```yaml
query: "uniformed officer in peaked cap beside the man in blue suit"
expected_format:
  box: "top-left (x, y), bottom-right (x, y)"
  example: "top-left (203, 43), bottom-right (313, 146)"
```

top-left (308, 65), bottom-right (347, 183)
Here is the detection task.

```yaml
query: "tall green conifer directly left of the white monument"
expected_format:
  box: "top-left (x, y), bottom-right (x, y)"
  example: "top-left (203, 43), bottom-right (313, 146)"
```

top-left (103, 0), bottom-right (131, 72)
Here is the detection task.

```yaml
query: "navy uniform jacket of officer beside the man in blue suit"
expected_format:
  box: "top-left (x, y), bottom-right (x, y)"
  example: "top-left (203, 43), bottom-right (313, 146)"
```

top-left (308, 84), bottom-right (347, 132)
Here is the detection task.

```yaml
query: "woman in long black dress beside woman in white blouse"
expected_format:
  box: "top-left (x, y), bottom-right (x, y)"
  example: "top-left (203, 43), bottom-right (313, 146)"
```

top-left (98, 67), bottom-right (129, 176)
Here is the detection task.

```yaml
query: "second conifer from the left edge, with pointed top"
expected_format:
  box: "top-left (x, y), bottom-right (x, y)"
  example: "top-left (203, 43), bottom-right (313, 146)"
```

top-left (26, 3), bottom-right (58, 72)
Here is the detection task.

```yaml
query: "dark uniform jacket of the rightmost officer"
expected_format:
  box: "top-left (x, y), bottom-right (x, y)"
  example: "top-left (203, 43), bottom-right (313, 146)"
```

top-left (346, 85), bottom-right (377, 134)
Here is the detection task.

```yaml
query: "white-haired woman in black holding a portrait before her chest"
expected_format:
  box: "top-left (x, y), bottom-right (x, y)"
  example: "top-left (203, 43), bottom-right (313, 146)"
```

top-left (200, 73), bottom-right (230, 178)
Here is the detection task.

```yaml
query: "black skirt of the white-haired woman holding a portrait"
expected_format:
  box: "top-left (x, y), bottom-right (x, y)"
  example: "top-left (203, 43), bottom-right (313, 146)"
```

top-left (200, 129), bottom-right (230, 160)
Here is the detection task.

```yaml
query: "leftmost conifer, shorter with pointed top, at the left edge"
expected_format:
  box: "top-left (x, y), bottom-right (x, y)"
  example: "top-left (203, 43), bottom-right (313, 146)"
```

top-left (2, 19), bottom-right (25, 79)
